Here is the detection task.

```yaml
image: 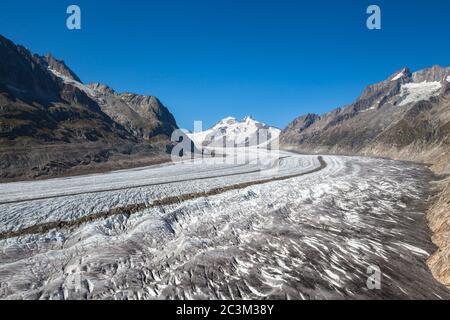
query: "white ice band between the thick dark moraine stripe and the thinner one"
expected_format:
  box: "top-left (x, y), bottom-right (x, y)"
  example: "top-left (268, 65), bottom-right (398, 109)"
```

top-left (0, 155), bottom-right (326, 232)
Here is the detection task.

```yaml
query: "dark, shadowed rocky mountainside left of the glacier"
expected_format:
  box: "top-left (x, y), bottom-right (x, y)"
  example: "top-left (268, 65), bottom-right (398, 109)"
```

top-left (0, 36), bottom-right (177, 180)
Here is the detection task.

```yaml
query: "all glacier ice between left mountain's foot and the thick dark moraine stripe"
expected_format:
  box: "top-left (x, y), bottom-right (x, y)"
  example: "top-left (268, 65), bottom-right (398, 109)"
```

top-left (0, 153), bottom-right (320, 232)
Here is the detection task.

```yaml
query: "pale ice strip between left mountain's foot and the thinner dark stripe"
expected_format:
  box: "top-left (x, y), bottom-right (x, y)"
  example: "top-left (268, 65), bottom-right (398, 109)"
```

top-left (0, 152), bottom-right (317, 205)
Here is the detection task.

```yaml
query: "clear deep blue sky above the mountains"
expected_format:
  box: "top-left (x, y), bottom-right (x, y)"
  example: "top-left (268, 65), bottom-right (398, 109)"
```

top-left (0, 0), bottom-right (450, 129)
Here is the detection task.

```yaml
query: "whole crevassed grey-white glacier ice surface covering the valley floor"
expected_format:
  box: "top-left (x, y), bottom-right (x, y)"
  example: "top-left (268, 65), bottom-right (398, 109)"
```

top-left (0, 153), bottom-right (449, 299)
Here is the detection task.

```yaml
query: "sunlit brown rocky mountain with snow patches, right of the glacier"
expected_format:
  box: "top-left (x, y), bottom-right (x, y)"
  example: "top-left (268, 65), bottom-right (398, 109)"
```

top-left (280, 66), bottom-right (450, 172)
